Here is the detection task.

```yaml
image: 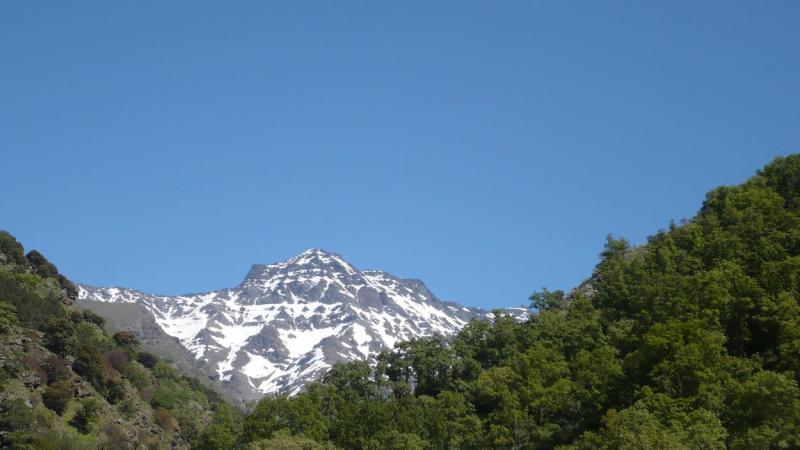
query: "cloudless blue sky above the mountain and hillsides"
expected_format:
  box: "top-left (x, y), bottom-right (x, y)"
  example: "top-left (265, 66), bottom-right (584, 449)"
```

top-left (0, 1), bottom-right (800, 307)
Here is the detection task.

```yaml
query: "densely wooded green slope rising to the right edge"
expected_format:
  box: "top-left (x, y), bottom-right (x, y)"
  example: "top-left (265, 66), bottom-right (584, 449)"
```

top-left (215, 156), bottom-right (800, 449)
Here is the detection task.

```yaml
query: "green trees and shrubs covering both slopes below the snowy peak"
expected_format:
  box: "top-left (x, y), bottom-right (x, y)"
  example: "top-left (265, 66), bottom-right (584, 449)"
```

top-left (0, 155), bottom-right (800, 450)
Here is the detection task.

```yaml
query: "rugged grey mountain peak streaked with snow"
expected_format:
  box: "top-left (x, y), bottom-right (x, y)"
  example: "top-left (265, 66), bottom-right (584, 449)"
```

top-left (79, 249), bottom-right (512, 398)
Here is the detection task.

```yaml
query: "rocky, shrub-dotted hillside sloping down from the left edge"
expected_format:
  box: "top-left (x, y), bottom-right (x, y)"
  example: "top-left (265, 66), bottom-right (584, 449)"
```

top-left (0, 232), bottom-right (235, 450)
